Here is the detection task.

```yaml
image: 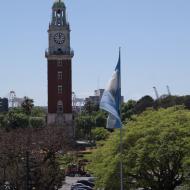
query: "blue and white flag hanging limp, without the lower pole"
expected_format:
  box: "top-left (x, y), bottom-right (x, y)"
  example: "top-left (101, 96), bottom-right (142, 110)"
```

top-left (100, 51), bottom-right (122, 129)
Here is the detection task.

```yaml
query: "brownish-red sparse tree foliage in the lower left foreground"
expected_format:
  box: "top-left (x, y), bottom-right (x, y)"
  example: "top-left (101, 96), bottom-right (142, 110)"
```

top-left (0, 128), bottom-right (72, 190)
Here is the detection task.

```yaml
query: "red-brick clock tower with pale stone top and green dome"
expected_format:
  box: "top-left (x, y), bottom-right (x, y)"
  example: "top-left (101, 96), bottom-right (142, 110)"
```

top-left (45, 0), bottom-right (74, 125)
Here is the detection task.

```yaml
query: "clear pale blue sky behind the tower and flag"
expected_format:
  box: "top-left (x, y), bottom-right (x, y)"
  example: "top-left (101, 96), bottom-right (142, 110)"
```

top-left (0, 0), bottom-right (190, 106)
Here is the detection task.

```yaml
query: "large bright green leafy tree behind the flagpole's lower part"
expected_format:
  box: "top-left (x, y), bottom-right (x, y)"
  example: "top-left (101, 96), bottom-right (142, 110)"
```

top-left (89, 107), bottom-right (190, 190)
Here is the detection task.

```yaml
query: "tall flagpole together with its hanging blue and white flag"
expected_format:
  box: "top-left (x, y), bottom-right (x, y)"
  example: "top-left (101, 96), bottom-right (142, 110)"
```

top-left (100, 48), bottom-right (123, 190)
